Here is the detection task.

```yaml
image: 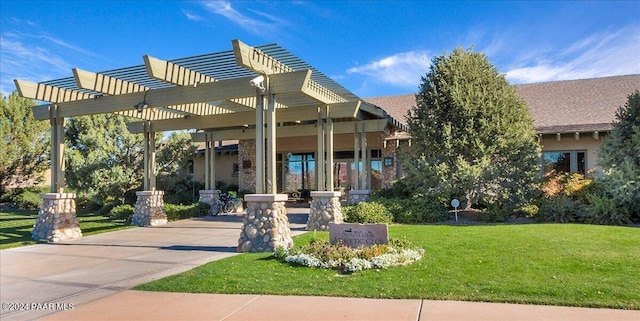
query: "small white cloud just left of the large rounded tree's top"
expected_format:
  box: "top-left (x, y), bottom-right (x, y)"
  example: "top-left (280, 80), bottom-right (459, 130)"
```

top-left (347, 51), bottom-right (431, 89)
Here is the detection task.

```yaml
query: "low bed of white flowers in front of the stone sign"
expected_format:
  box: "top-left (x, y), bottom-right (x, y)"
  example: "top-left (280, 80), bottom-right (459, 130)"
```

top-left (273, 239), bottom-right (424, 273)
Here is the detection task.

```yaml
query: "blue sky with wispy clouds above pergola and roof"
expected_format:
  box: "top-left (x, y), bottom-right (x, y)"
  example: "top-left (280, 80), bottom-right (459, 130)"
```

top-left (0, 0), bottom-right (640, 97)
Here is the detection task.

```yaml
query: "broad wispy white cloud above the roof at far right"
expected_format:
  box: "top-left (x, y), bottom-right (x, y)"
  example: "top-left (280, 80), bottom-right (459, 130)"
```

top-left (506, 26), bottom-right (640, 83)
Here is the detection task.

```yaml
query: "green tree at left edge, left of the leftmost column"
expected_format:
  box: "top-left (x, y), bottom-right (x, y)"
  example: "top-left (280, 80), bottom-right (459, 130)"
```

top-left (0, 92), bottom-right (50, 192)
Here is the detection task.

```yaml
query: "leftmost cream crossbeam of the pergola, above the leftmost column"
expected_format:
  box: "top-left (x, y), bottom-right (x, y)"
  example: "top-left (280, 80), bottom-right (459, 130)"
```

top-left (14, 79), bottom-right (95, 102)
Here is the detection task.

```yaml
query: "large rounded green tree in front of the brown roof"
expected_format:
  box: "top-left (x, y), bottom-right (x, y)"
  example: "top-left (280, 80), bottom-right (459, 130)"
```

top-left (403, 48), bottom-right (540, 210)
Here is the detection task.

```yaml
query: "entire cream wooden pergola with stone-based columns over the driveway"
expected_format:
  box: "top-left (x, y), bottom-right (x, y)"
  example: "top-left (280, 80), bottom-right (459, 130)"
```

top-left (16, 40), bottom-right (401, 251)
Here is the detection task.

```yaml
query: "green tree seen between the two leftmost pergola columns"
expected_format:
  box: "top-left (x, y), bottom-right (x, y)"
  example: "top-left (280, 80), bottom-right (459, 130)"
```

top-left (65, 114), bottom-right (144, 204)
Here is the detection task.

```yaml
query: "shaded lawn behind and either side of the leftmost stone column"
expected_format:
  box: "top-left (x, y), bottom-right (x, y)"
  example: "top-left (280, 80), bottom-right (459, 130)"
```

top-left (0, 209), bottom-right (130, 249)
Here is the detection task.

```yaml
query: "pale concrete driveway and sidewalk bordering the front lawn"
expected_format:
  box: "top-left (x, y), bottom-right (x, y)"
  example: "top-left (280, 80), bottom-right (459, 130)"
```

top-left (0, 208), bottom-right (640, 321)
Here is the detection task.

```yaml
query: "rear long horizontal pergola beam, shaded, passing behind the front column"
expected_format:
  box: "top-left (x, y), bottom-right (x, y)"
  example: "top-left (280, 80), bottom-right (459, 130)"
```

top-left (127, 101), bottom-right (362, 133)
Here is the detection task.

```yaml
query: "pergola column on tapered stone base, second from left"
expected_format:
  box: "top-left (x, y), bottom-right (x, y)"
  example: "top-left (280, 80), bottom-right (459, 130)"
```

top-left (131, 122), bottom-right (167, 226)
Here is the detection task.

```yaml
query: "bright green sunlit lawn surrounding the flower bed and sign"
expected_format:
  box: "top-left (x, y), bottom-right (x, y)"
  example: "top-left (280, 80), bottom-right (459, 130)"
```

top-left (136, 224), bottom-right (640, 309)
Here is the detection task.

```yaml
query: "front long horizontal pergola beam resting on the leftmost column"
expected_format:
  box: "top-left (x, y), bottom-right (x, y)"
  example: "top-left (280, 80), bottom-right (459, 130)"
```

top-left (32, 70), bottom-right (311, 119)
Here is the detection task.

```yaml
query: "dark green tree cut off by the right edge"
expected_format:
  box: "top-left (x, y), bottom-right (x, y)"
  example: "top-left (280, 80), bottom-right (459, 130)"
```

top-left (598, 91), bottom-right (640, 218)
